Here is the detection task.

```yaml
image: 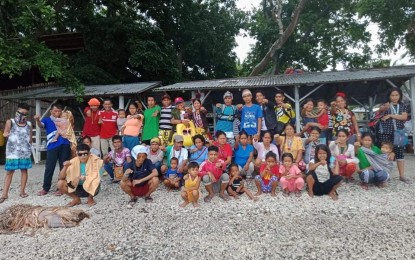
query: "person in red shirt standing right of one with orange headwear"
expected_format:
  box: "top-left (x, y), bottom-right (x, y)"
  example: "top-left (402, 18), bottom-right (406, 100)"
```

top-left (98, 99), bottom-right (118, 156)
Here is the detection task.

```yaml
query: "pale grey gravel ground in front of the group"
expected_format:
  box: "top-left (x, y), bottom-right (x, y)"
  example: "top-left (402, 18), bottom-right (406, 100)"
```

top-left (0, 155), bottom-right (415, 260)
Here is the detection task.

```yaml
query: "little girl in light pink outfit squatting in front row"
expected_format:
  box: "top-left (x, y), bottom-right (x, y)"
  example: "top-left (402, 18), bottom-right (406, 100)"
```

top-left (280, 153), bottom-right (304, 197)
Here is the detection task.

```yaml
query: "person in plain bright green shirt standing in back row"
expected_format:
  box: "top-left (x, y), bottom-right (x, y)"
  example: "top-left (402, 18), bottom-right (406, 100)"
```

top-left (141, 96), bottom-right (161, 145)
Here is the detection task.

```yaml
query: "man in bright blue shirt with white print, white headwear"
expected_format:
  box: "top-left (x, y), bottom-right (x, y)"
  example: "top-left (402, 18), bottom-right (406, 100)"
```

top-left (240, 89), bottom-right (262, 140)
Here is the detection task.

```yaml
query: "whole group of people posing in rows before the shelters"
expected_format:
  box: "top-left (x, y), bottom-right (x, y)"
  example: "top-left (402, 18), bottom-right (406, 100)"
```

top-left (0, 88), bottom-right (408, 208)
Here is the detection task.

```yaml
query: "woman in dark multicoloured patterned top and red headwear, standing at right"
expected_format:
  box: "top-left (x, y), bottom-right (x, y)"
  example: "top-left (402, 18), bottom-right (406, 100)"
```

top-left (331, 92), bottom-right (360, 144)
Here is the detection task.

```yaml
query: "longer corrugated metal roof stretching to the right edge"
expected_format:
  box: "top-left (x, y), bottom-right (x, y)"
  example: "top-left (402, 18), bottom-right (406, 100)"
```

top-left (153, 66), bottom-right (415, 91)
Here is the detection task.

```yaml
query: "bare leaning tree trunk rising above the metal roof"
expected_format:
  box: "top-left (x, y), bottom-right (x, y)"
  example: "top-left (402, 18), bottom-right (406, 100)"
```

top-left (250, 0), bottom-right (308, 76)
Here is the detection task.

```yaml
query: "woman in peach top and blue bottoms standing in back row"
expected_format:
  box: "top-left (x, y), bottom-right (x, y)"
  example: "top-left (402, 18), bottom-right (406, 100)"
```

top-left (121, 102), bottom-right (143, 151)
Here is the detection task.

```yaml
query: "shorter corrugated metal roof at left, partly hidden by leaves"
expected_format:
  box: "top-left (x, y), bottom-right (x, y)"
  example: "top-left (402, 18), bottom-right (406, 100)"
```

top-left (0, 82), bottom-right (161, 99)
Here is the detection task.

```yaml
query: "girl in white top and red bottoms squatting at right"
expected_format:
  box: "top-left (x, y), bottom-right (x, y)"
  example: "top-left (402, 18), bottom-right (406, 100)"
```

top-left (329, 129), bottom-right (359, 181)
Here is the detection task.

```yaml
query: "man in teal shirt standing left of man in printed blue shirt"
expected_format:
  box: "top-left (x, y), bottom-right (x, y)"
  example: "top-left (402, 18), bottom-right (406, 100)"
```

top-left (215, 91), bottom-right (239, 148)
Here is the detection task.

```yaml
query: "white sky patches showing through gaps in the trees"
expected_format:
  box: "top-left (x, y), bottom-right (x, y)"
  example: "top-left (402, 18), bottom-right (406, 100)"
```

top-left (234, 0), bottom-right (414, 66)
